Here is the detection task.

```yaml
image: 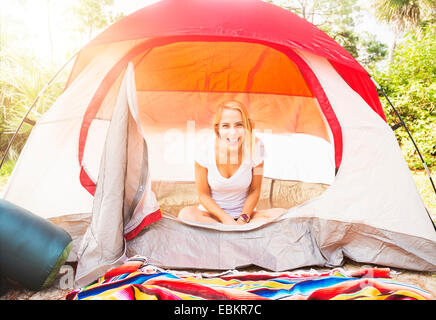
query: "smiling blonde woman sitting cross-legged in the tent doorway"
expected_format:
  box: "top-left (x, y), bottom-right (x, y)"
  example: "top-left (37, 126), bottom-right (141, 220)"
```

top-left (179, 101), bottom-right (285, 225)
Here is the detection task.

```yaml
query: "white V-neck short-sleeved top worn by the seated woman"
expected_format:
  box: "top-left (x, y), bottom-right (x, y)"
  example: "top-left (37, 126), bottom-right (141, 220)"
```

top-left (195, 137), bottom-right (265, 219)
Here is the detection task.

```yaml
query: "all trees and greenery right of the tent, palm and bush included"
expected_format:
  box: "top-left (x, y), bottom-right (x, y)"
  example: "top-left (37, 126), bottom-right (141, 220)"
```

top-left (267, 0), bottom-right (436, 169)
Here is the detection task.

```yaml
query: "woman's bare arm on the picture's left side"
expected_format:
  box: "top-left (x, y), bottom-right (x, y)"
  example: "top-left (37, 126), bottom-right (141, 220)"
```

top-left (195, 162), bottom-right (235, 224)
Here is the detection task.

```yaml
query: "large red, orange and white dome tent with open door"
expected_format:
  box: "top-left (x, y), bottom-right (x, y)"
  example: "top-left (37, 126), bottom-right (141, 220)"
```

top-left (4, 0), bottom-right (436, 284)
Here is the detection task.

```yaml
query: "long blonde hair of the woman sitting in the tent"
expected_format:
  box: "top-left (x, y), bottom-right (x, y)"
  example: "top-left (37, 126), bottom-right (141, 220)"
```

top-left (213, 100), bottom-right (254, 160)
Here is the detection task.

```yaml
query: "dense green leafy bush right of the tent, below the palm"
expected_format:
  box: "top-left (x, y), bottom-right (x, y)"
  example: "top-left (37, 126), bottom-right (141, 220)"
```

top-left (374, 25), bottom-right (436, 169)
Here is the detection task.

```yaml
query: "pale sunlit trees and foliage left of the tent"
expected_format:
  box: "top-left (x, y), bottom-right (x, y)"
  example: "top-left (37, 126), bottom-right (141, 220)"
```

top-left (0, 0), bottom-right (122, 164)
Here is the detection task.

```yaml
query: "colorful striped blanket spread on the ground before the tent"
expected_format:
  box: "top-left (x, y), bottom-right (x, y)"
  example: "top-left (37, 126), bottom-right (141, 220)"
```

top-left (67, 266), bottom-right (433, 300)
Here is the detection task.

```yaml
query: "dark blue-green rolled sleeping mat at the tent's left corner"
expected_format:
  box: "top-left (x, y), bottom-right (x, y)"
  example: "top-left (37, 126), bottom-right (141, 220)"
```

top-left (0, 199), bottom-right (72, 291)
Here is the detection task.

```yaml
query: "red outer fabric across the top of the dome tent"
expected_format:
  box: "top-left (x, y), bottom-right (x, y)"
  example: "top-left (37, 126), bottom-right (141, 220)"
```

top-left (68, 0), bottom-right (385, 119)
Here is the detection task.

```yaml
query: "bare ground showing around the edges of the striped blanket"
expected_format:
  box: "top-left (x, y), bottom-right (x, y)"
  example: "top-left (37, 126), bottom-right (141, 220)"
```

top-left (0, 259), bottom-right (436, 300)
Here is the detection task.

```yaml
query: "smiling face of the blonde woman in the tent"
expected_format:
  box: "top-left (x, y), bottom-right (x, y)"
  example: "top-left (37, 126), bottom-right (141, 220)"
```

top-left (218, 108), bottom-right (245, 150)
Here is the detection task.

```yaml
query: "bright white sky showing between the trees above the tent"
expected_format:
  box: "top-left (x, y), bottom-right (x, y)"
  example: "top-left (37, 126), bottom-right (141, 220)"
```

top-left (0, 0), bottom-right (392, 65)
